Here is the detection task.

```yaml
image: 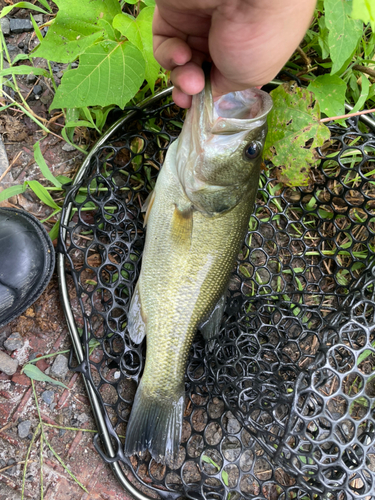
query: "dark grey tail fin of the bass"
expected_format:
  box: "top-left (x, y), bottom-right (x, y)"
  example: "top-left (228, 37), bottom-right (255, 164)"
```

top-left (125, 382), bottom-right (185, 465)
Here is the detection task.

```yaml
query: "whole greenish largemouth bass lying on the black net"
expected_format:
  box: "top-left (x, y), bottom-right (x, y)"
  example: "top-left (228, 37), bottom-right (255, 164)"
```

top-left (124, 78), bottom-right (272, 465)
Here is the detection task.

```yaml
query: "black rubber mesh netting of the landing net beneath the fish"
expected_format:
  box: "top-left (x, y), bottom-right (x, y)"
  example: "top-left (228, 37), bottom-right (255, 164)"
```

top-left (60, 94), bottom-right (375, 500)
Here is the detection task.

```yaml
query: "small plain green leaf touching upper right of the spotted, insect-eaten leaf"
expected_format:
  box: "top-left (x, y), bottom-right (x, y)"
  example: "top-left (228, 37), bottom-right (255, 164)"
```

top-left (307, 75), bottom-right (346, 121)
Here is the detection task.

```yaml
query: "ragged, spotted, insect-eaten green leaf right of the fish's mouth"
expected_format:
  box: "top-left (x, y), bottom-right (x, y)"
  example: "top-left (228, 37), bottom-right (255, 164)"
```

top-left (264, 84), bottom-right (330, 186)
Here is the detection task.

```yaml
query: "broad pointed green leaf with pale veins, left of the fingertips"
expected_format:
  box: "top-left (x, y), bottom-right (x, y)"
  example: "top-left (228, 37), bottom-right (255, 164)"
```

top-left (51, 40), bottom-right (145, 109)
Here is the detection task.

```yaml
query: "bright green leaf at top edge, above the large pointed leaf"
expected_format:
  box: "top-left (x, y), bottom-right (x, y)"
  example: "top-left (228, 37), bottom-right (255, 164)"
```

top-left (34, 0), bottom-right (121, 63)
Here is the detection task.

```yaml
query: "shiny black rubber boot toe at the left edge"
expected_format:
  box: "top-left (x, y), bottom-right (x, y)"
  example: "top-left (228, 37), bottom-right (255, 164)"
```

top-left (0, 208), bottom-right (55, 327)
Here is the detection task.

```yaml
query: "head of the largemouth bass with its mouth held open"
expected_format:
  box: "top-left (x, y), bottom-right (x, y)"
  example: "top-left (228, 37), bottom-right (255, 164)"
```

top-left (176, 80), bottom-right (272, 215)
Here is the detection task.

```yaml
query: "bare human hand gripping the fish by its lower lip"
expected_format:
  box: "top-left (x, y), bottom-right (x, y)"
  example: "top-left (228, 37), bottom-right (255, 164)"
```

top-left (153, 0), bottom-right (316, 108)
